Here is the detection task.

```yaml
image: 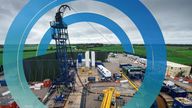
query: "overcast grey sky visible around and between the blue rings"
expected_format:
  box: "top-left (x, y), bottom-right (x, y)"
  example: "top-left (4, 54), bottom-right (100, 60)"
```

top-left (0, 0), bottom-right (192, 44)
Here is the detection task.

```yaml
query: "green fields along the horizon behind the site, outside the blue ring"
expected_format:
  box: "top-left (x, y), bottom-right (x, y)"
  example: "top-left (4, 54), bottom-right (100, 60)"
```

top-left (0, 45), bottom-right (192, 65)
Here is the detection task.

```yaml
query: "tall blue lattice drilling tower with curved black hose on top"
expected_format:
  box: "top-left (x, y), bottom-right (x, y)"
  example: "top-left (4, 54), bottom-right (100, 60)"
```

top-left (50, 5), bottom-right (73, 84)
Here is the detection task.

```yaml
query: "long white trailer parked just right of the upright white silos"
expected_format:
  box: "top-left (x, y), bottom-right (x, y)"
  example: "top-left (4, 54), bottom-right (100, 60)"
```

top-left (97, 65), bottom-right (112, 79)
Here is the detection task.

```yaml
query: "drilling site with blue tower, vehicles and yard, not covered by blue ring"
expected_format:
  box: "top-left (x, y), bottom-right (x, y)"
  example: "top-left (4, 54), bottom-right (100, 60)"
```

top-left (0, 5), bottom-right (192, 108)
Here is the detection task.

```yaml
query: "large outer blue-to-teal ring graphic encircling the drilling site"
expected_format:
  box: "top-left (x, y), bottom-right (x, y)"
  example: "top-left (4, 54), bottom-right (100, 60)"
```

top-left (3, 0), bottom-right (166, 108)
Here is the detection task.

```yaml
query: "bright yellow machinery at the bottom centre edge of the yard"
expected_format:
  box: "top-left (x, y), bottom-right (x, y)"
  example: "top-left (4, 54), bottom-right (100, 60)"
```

top-left (101, 87), bottom-right (120, 108)
